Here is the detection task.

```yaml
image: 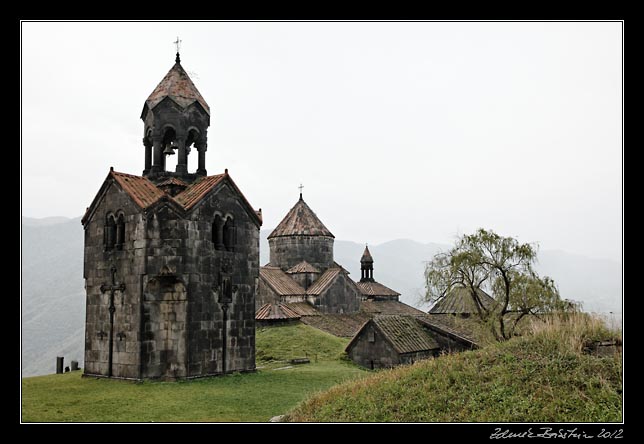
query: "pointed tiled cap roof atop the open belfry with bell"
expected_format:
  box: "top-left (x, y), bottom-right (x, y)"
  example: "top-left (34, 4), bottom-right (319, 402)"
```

top-left (142, 62), bottom-right (210, 117)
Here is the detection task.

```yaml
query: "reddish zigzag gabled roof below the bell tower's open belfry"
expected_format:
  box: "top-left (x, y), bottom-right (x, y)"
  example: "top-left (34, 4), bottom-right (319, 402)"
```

top-left (81, 169), bottom-right (262, 226)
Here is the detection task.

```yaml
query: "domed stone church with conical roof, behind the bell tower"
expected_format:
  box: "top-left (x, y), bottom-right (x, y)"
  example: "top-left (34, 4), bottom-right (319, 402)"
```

top-left (256, 193), bottom-right (423, 320)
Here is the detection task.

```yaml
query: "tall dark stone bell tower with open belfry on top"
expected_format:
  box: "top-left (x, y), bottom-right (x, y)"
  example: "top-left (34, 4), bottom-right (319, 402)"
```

top-left (82, 54), bottom-right (262, 379)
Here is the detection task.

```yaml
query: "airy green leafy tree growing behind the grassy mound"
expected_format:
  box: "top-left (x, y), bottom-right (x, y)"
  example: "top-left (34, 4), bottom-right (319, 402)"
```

top-left (425, 229), bottom-right (571, 339)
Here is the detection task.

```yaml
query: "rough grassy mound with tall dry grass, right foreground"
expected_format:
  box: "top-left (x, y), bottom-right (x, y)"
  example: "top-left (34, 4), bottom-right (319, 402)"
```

top-left (288, 314), bottom-right (622, 422)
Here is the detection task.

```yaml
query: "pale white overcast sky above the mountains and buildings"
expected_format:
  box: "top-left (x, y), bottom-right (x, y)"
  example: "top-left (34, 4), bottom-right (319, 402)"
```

top-left (21, 22), bottom-right (622, 260)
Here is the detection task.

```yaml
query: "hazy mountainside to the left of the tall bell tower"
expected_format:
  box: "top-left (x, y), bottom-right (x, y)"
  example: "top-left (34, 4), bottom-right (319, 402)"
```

top-left (21, 218), bottom-right (85, 376)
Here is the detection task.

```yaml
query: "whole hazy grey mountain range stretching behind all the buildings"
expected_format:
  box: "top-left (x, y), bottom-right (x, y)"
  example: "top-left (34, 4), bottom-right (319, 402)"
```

top-left (21, 217), bottom-right (622, 376)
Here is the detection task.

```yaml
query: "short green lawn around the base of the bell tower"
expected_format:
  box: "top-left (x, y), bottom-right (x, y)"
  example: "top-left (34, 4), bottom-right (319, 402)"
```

top-left (22, 325), bottom-right (366, 422)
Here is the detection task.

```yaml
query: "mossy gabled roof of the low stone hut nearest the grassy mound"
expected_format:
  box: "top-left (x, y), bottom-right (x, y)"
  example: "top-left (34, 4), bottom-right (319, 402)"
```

top-left (346, 315), bottom-right (440, 354)
